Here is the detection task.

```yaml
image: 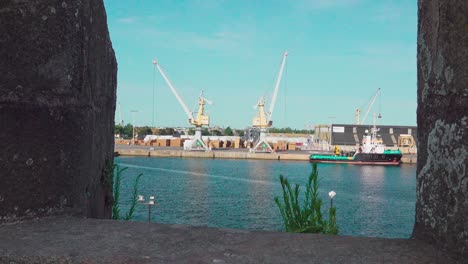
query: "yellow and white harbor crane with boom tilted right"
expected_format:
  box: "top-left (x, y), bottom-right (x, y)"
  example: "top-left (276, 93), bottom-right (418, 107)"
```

top-left (251, 51), bottom-right (288, 152)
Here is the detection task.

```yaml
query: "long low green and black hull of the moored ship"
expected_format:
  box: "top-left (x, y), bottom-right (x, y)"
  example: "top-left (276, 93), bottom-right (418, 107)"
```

top-left (309, 153), bottom-right (402, 166)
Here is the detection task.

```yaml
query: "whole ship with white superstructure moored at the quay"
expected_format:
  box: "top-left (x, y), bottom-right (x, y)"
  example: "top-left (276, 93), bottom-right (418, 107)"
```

top-left (309, 115), bottom-right (403, 166)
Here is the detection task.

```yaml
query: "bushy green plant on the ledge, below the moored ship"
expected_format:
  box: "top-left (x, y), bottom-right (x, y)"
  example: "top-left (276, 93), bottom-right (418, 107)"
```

top-left (275, 163), bottom-right (338, 235)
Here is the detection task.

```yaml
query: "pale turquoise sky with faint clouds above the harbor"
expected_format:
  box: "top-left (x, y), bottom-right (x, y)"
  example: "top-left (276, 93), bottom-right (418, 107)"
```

top-left (104, 0), bottom-right (417, 129)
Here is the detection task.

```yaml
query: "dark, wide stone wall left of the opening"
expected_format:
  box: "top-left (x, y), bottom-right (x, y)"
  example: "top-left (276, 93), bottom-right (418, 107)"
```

top-left (0, 0), bottom-right (117, 222)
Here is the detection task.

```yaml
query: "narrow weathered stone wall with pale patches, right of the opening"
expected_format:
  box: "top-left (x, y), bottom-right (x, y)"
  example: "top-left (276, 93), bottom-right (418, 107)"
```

top-left (413, 0), bottom-right (468, 257)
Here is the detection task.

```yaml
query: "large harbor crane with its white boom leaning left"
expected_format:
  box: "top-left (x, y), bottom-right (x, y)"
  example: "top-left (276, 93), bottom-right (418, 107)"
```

top-left (153, 60), bottom-right (213, 151)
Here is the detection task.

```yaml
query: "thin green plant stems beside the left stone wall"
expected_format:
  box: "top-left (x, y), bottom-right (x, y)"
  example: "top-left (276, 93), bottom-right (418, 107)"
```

top-left (112, 164), bottom-right (143, 220)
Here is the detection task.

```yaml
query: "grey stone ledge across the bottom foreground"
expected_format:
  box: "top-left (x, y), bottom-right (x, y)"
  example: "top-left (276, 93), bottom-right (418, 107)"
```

top-left (0, 216), bottom-right (461, 263)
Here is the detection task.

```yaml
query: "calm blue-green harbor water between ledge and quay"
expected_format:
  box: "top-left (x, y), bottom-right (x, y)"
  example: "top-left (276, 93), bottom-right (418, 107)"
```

top-left (115, 157), bottom-right (416, 238)
